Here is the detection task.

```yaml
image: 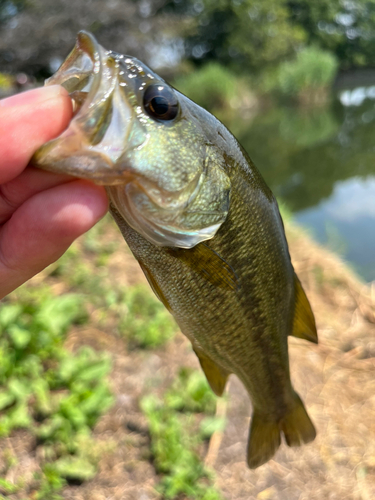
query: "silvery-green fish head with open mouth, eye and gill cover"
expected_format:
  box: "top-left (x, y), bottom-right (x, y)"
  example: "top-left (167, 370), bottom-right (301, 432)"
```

top-left (32, 32), bottom-right (230, 248)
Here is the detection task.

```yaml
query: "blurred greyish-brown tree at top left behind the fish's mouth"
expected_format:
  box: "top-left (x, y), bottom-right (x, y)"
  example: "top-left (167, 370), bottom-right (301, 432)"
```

top-left (0, 0), bottom-right (170, 77)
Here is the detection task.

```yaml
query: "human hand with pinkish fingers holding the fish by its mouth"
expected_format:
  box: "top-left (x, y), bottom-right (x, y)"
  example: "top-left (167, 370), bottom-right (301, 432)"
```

top-left (0, 85), bottom-right (108, 299)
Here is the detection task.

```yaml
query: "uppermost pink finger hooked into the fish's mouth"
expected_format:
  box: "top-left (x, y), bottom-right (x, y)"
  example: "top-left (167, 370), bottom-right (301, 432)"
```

top-left (0, 85), bottom-right (72, 184)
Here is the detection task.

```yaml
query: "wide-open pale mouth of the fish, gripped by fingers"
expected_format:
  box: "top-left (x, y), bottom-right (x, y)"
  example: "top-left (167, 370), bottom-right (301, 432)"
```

top-left (32, 31), bottom-right (141, 185)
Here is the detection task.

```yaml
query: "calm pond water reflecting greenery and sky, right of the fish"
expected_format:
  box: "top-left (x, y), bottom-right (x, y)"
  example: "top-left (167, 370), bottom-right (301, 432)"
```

top-left (232, 86), bottom-right (375, 281)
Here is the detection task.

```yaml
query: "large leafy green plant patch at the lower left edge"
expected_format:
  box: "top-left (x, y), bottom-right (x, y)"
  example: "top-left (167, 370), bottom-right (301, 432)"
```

top-left (0, 287), bottom-right (113, 500)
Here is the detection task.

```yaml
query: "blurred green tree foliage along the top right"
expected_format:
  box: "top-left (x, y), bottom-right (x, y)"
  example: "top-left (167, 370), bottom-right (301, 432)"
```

top-left (163, 0), bottom-right (375, 72)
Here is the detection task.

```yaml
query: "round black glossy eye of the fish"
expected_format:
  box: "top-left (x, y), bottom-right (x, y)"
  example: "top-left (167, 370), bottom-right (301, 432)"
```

top-left (143, 85), bottom-right (179, 121)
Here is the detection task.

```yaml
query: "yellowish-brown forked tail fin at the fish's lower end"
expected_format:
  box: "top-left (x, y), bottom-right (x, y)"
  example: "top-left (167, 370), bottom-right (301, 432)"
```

top-left (247, 394), bottom-right (316, 469)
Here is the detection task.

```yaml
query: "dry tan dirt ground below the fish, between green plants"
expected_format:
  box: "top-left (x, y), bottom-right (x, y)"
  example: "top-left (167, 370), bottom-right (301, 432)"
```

top-left (0, 220), bottom-right (375, 500)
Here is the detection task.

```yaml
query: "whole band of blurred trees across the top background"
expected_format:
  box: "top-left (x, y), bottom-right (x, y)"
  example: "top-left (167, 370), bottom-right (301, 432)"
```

top-left (0, 0), bottom-right (375, 76)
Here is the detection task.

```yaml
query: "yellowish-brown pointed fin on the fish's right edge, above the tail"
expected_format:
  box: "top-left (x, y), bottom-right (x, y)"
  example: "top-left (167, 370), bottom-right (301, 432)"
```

top-left (291, 273), bottom-right (318, 344)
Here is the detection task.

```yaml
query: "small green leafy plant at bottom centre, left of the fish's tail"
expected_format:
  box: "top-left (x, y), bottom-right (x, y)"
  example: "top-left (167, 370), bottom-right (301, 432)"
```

top-left (141, 369), bottom-right (224, 500)
